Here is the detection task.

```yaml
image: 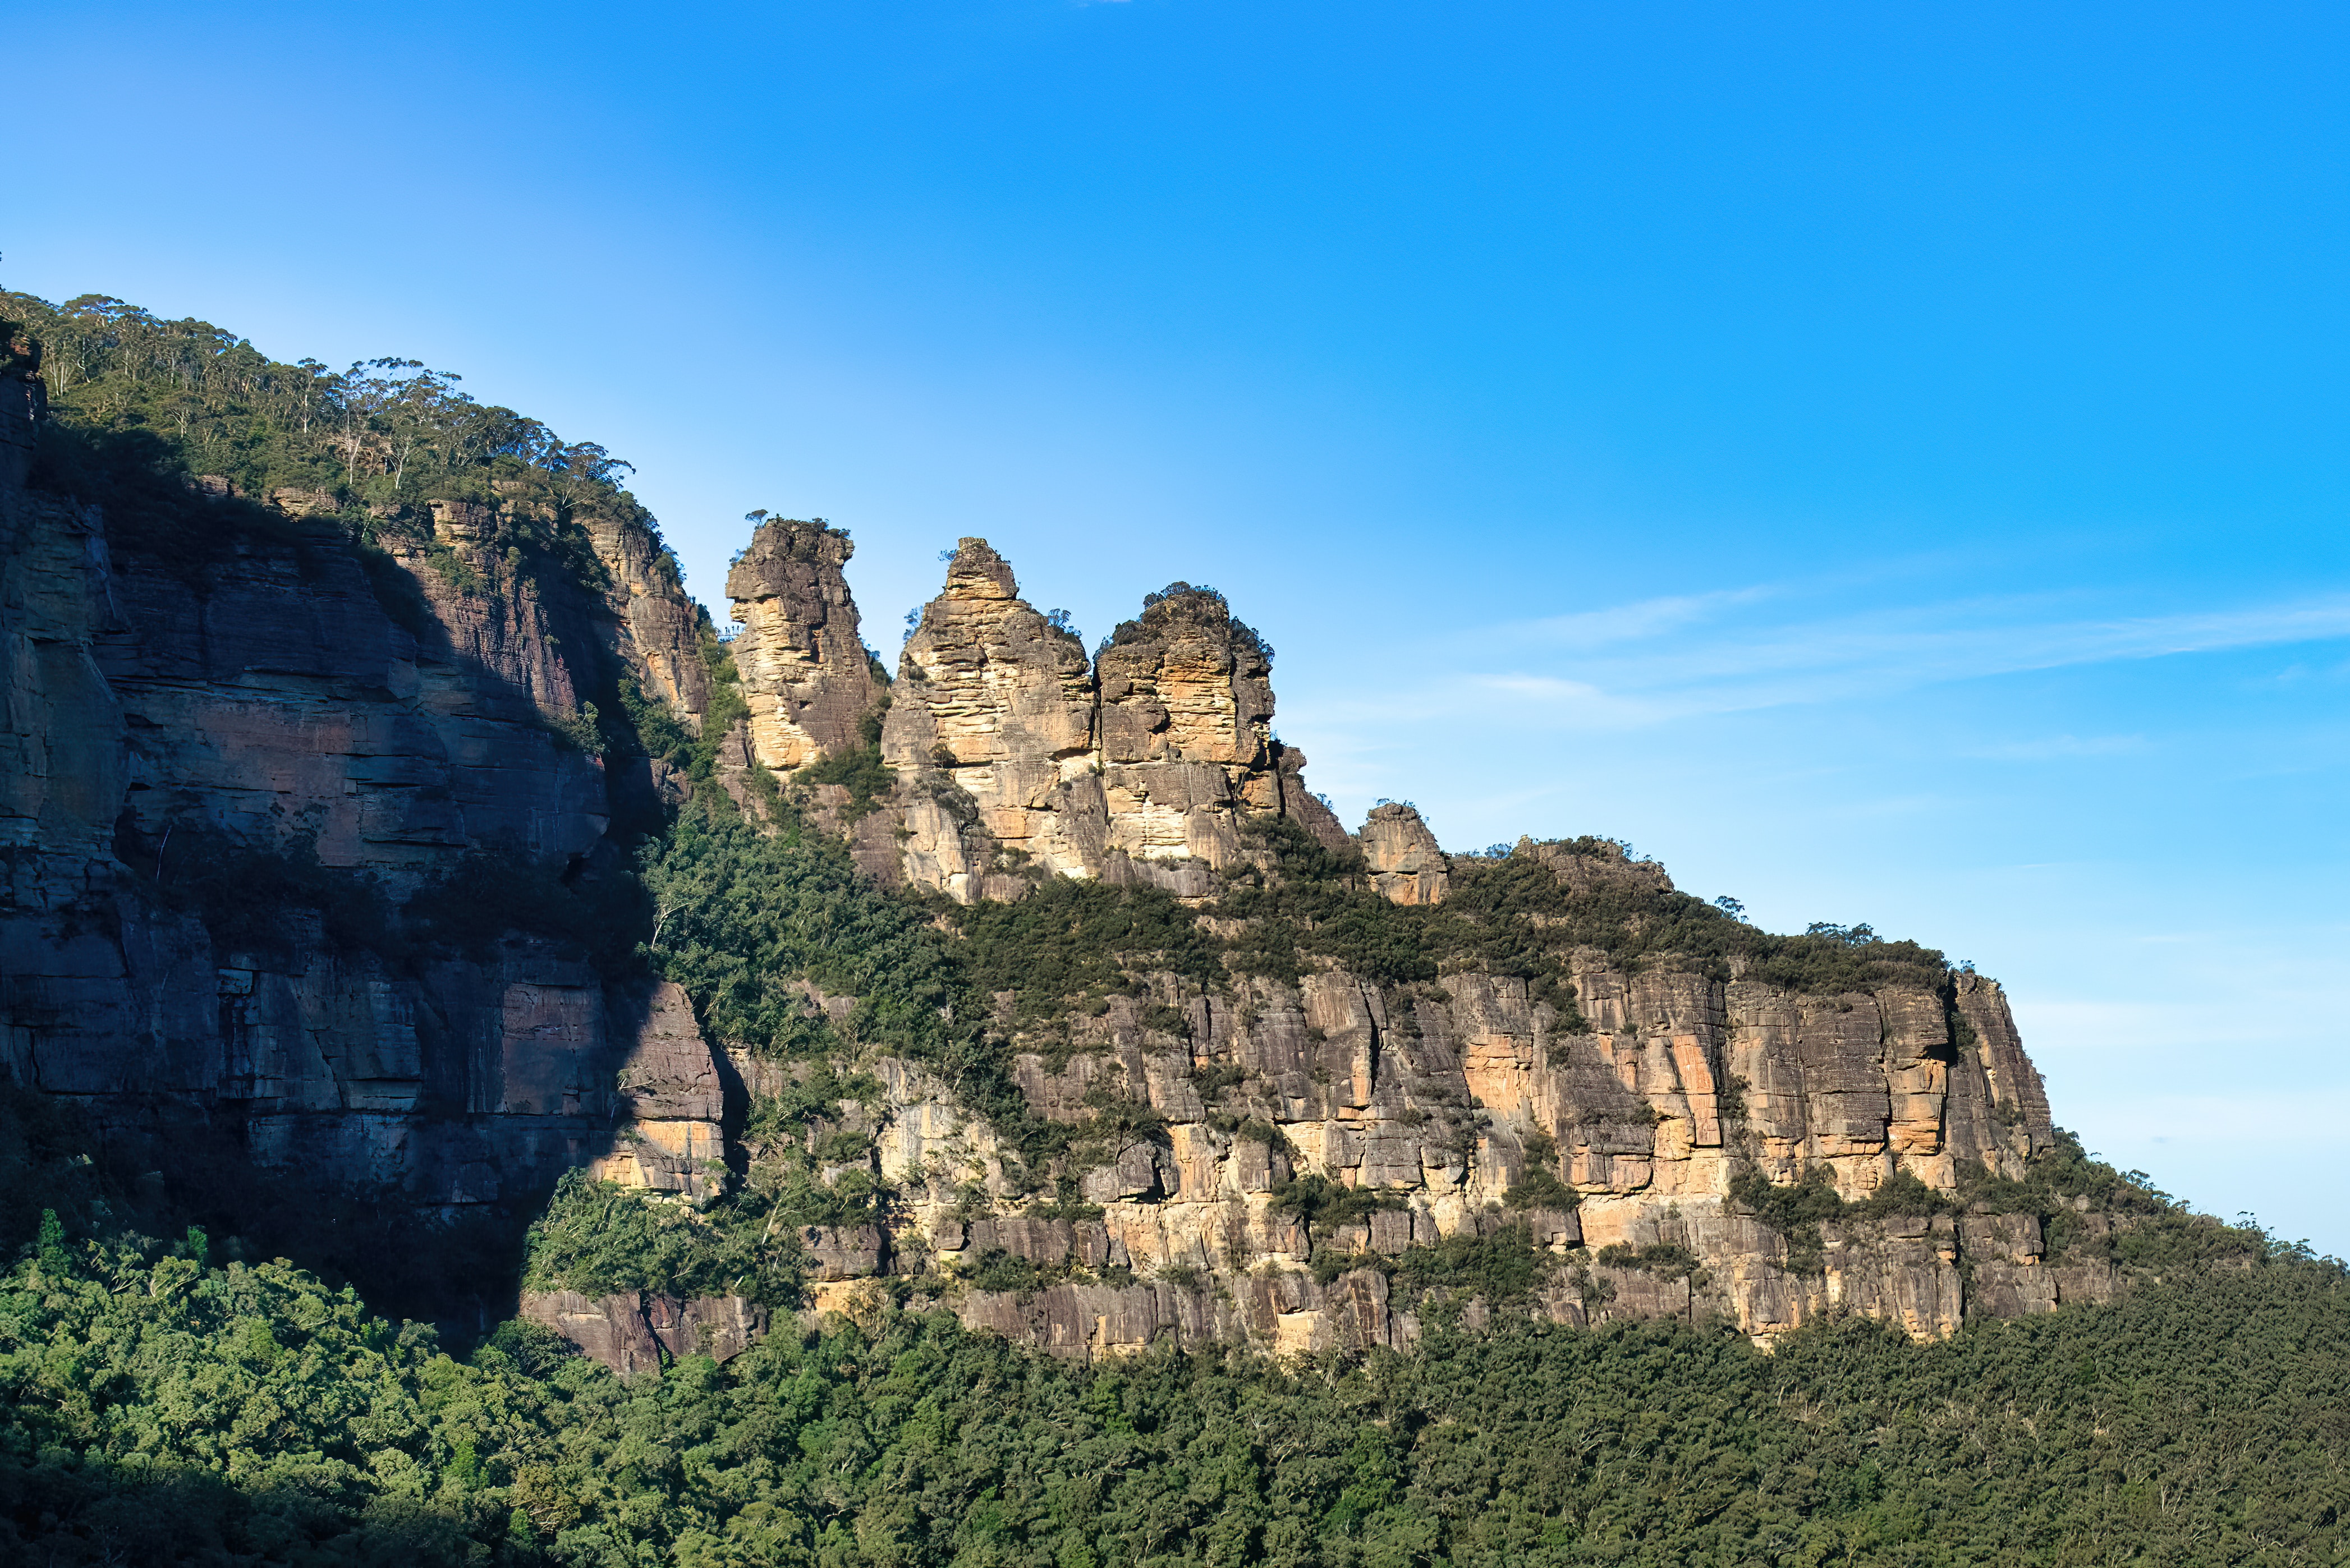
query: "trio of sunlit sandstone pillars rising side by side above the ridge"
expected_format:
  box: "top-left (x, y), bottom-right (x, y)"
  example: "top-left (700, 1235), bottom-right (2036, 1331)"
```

top-left (728, 542), bottom-right (1353, 903)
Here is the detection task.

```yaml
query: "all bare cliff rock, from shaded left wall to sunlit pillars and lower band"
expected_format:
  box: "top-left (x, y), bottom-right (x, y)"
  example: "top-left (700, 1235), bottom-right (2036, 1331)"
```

top-left (0, 324), bottom-right (2115, 1368)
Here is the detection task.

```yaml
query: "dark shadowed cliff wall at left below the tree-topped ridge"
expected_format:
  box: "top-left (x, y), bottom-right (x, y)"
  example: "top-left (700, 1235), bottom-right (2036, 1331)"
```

top-left (0, 345), bottom-right (717, 1326)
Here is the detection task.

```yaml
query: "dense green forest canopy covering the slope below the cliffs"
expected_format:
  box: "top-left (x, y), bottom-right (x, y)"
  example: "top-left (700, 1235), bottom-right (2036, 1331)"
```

top-left (0, 1072), bottom-right (2350, 1568)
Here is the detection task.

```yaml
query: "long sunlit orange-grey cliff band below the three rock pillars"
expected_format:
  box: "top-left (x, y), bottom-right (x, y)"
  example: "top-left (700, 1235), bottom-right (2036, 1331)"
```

top-left (766, 842), bottom-right (2077, 1357)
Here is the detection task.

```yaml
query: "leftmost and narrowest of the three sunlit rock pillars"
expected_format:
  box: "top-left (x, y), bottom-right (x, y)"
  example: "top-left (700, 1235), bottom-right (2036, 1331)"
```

top-left (726, 517), bottom-right (882, 771)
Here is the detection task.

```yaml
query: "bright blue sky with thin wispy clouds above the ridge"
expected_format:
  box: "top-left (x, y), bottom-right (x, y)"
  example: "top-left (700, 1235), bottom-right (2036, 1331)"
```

top-left (0, 0), bottom-right (2350, 1253)
